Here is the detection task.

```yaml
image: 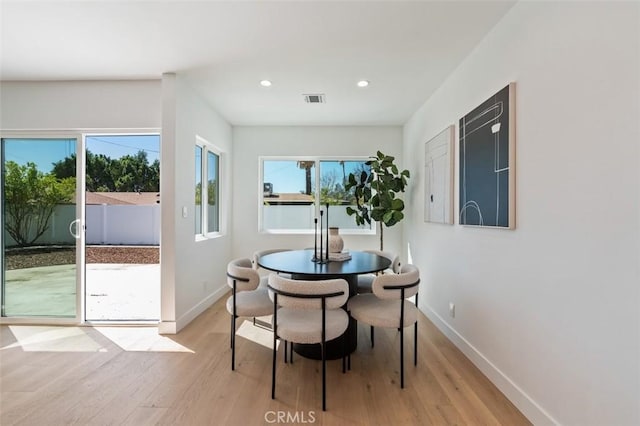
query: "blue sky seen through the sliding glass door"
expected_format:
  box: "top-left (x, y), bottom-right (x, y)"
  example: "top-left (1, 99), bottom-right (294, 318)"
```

top-left (3, 135), bottom-right (160, 173)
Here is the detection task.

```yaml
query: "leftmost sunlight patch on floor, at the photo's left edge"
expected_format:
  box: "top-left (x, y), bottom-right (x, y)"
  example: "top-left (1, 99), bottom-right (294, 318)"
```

top-left (0, 325), bottom-right (107, 352)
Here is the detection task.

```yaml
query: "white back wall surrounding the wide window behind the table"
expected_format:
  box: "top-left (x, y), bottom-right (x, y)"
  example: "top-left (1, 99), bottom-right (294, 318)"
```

top-left (233, 126), bottom-right (402, 258)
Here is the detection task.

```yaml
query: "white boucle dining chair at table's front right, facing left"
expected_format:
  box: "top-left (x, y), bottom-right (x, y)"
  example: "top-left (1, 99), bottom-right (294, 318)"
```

top-left (347, 265), bottom-right (420, 388)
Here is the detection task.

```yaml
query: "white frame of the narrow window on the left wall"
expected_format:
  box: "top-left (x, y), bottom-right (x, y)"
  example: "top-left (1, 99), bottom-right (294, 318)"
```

top-left (194, 135), bottom-right (226, 241)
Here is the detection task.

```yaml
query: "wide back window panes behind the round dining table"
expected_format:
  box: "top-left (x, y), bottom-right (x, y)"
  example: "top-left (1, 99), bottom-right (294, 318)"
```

top-left (259, 157), bottom-right (375, 233)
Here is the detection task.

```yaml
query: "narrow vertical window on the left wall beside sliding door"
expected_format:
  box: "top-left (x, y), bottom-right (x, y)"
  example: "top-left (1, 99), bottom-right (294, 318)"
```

top-left (195, 137), bottom-right (221, 238)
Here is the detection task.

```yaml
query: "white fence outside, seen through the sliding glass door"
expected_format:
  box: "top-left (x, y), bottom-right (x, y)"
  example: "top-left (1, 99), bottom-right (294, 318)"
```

top-left (5, 204), bottom-right (160, 247)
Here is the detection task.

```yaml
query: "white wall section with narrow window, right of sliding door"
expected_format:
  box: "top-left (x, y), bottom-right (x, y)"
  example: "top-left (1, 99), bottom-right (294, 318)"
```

top-left (160, 74), bottom-right (232, 333)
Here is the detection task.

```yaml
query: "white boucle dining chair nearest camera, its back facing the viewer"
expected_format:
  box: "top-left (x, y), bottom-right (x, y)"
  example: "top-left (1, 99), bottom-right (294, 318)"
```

top-left (269, 273), bottom-right (349, 411)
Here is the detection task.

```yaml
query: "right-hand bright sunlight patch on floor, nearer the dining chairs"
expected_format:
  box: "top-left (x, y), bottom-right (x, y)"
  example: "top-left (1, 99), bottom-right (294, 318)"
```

top-left (95, 327), bottom-right (194, 353)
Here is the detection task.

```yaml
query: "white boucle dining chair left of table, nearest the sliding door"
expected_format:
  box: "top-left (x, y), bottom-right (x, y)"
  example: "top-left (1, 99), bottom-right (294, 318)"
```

top-left (227, 258), bottom-right (273, 370)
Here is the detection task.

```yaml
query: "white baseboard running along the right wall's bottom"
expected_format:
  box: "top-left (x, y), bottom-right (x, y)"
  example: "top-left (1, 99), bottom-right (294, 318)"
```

top-left (421, 306), bottom-right (559, 425)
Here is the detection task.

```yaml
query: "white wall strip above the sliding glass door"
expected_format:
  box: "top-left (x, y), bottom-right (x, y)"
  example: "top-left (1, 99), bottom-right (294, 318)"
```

top-left (0, 80), bottom-right (161, 130)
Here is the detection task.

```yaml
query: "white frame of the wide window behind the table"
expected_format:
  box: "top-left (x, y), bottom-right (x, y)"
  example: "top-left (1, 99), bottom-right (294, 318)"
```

top-left (258, 155), bottom-right (377, 235)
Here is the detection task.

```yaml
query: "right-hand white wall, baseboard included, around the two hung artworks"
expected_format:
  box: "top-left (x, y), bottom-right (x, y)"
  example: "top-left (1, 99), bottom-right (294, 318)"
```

top-left (404, 2), bottom-right (640, 425)
